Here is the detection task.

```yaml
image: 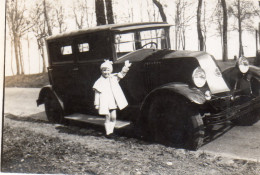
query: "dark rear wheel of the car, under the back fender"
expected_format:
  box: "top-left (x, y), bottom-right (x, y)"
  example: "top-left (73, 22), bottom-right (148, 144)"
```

top-left (44, 95), bottom-right (64, 123)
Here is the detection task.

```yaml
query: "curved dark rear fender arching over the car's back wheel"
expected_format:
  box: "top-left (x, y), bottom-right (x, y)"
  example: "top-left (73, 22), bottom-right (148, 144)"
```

top-left (36, 85), bottom-right (64, 110)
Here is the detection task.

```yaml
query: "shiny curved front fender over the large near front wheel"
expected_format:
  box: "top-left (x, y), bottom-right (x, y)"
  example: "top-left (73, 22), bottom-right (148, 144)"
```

top-left (141, 83), bottom-right (206, 109)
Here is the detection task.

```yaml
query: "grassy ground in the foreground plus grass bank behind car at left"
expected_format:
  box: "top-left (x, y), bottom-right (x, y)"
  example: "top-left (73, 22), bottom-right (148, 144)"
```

top-left (2, 69), bottom-right (260, 175)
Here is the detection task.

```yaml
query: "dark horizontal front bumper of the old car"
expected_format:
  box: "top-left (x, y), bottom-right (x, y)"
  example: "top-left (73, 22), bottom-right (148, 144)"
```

top-left (203, 97), bottom-right (260, 126)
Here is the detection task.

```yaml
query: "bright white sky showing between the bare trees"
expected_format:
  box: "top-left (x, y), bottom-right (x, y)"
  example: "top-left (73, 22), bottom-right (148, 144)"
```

top-left (5, 0), bottom-right (260, 76)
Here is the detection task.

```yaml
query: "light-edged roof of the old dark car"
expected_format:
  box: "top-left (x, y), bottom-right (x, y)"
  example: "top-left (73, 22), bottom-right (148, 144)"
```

top-left (46, 22), bottom-right (172, 40)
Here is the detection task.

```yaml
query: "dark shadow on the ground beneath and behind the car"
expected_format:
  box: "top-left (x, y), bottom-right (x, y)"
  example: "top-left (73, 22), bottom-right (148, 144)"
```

top-left (5, 112), bottom-right (234, 150)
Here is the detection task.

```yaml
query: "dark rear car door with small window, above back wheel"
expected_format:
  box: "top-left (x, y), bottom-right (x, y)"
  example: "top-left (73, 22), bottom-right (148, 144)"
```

top-left (48, 38), bottom-right (77, 114)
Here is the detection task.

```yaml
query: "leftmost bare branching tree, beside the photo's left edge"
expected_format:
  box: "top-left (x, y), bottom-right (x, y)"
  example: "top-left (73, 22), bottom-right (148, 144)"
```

top-left (6, 0), bottom-right (32, 75)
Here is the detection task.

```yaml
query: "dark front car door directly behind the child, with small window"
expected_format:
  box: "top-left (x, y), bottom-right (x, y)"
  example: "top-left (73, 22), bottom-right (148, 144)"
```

top-left (75, 32), bottom-right (112, 114)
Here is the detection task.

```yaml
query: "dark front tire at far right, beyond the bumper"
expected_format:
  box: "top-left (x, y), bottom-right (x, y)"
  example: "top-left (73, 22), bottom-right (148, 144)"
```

top-left (231, 110), bottom-right (260, 126)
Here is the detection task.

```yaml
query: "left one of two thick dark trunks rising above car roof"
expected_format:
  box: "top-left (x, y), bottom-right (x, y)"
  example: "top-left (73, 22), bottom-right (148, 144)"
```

top-left (95, 0), bottom-right (106, 26)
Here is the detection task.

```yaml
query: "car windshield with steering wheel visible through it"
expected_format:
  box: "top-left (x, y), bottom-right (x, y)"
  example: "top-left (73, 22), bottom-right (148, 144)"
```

top-left (115, 29), bottom-right (167, 59)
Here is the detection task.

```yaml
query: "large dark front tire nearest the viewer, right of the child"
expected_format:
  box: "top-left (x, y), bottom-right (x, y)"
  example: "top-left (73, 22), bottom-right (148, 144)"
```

top-left (146, 96), bottom-right (204, 150)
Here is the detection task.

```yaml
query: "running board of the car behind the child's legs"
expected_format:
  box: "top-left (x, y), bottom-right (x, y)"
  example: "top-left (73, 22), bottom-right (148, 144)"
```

top-left (64, 113), bottom-right (130, 129)
